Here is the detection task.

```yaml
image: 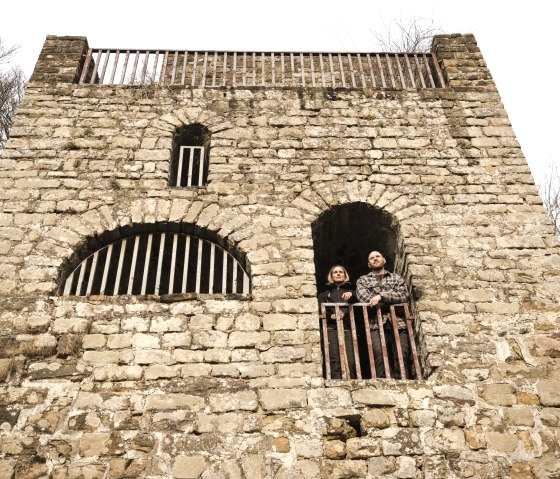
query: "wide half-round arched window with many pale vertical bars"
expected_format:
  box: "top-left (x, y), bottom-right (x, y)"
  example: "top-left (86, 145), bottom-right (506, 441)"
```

top-left (60, 224), bottom-right (250, 296)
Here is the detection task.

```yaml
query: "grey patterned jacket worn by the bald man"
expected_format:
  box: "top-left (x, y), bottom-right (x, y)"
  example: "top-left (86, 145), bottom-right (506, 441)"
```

top-left (356, 271), bottom-right (409, 329)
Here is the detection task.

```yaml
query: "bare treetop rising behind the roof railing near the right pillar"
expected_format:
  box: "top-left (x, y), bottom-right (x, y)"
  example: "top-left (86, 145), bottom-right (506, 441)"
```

top-left (372, 17), bottom-right (443, 52)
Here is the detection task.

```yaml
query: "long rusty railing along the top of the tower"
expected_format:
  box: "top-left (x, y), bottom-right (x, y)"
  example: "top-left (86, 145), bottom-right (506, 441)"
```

top-left (79, 48), bottom-right (445, 90)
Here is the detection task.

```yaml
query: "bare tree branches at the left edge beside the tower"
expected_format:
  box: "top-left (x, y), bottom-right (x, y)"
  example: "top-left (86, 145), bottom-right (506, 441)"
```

top-left (0, 38), bottom-right (25, 153)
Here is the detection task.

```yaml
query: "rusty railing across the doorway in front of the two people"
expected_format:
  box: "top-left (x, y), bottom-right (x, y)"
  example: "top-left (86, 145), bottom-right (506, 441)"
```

top-left (321, 303), bottom-right (422, 380)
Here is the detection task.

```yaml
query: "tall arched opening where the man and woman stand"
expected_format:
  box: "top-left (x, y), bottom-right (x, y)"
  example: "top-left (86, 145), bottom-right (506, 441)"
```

top-left (312, 202), bottom-right (421, 379)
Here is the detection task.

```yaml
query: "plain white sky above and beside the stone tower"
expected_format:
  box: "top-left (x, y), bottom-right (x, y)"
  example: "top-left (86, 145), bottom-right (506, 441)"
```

top-left (0, 0), bottom-right (560, 186)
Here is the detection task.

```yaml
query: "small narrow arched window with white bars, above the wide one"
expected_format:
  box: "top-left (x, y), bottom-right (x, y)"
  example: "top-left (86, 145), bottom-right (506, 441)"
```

top-left (169, 123), bottom-right (210, 187)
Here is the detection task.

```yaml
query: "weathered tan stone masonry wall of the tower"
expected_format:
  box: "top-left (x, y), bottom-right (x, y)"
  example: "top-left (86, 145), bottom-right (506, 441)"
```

top-left (0, 35), bottom-right (560, 479)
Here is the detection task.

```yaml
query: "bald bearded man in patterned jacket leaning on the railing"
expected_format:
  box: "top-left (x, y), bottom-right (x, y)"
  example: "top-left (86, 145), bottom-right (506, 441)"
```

top-left (356, 251), bottom-right (411, 378)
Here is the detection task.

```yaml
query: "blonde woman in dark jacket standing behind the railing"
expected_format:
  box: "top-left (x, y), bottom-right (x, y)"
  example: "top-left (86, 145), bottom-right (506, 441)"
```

top-left (318, 264), bottom-right (356, 379)
